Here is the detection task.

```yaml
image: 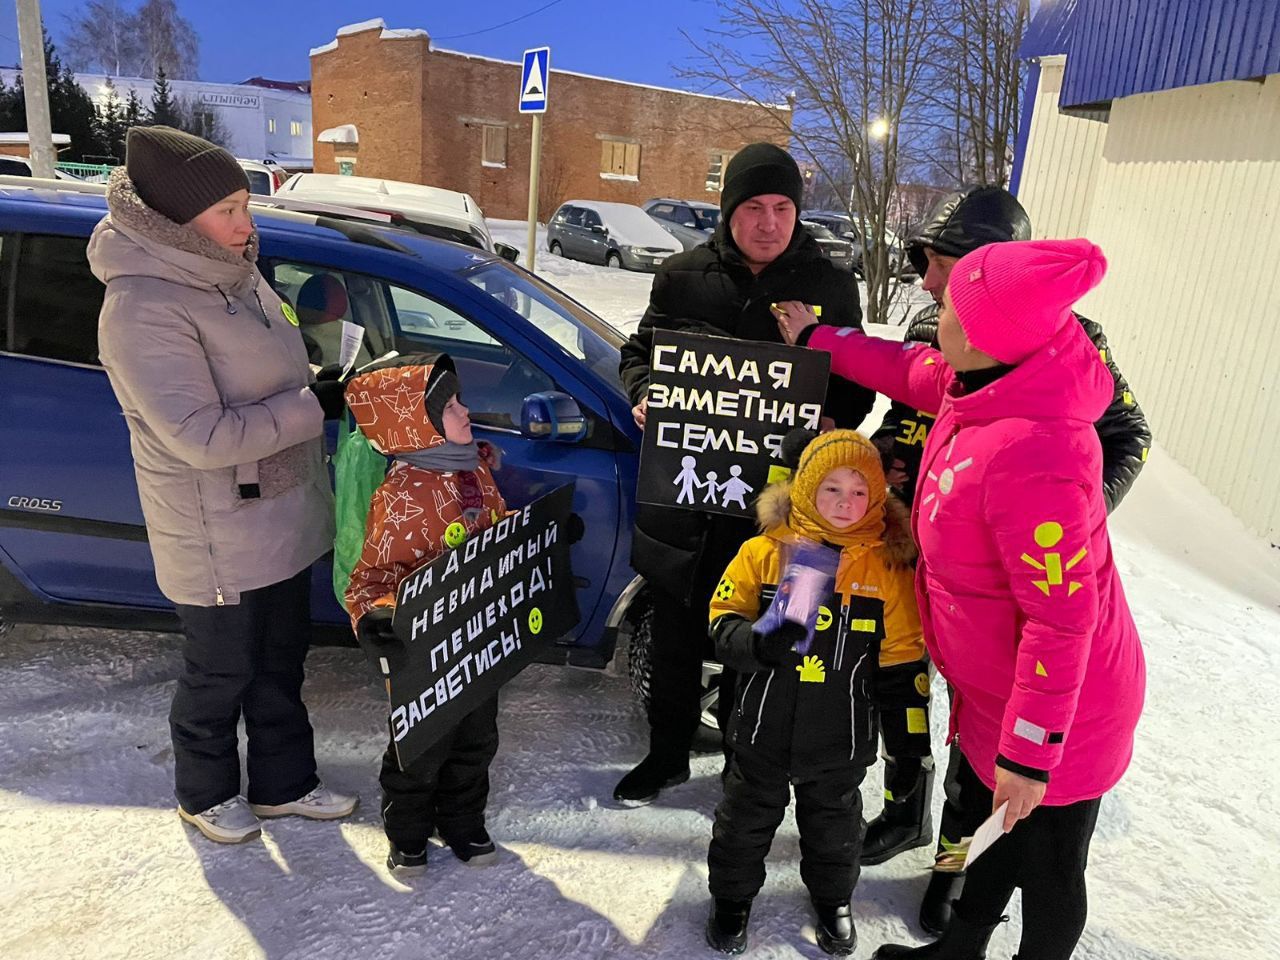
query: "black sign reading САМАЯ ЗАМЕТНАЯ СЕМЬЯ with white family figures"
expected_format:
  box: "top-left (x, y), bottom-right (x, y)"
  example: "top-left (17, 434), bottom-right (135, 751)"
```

top-left (636, 330), bottom-right (831, 516)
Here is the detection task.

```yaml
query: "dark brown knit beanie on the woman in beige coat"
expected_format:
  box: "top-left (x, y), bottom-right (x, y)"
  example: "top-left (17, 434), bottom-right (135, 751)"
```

top-left (124, 127), bottom-right (248, 223)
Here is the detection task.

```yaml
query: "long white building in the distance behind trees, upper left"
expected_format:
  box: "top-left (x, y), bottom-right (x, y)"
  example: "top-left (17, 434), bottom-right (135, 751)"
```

top-left (0, 69), bottom-right (312, 170)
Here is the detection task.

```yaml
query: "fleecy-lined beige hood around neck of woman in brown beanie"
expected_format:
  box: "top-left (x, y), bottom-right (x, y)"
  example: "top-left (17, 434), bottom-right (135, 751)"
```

top-left (88, 166), bottom-right (259, 292)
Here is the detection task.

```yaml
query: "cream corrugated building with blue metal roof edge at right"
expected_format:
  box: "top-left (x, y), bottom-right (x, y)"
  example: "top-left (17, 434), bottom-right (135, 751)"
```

top-left (1014, 0), bottom-right (1280, 544)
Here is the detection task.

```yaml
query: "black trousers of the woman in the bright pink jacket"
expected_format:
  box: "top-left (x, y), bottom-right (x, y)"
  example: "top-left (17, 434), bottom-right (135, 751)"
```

top-left (956, 756), bottom-right (1102, 960)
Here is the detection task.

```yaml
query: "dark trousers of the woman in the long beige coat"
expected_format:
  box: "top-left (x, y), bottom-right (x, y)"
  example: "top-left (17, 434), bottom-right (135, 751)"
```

top-left (169, 568), bottom-right (320, 813)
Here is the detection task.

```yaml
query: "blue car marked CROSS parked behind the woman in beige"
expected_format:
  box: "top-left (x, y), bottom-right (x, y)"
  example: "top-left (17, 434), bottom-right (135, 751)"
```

top-left (0, 180), bottom-right (643, 667)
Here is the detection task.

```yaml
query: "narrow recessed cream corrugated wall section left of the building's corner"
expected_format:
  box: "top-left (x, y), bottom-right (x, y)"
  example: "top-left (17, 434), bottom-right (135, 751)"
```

top-left (1018, 56), bottom-right (1107, 238)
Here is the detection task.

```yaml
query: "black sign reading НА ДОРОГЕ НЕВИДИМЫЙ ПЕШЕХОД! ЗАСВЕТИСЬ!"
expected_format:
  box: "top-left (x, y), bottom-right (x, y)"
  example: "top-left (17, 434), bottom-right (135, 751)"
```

top-left (388, 484), bottom-right (579, 769)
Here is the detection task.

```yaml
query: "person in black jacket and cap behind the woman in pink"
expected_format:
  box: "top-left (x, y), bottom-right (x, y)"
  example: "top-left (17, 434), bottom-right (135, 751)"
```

top-left (861, 187), bottom-right (1151, 936)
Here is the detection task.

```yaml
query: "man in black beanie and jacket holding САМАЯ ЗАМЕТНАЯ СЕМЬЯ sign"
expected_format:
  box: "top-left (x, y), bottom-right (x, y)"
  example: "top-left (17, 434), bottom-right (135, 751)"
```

top-left (613, 143), bottom-right (876, 805)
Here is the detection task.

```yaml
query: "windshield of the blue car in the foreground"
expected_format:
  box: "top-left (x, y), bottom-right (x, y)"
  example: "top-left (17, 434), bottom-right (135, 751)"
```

top-left (461, 260), bottom-right (626, 390)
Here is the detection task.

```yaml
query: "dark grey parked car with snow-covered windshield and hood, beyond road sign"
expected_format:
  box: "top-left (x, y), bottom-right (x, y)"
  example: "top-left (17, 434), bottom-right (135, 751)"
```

top-left (547, 200), bottom-right (684, 270)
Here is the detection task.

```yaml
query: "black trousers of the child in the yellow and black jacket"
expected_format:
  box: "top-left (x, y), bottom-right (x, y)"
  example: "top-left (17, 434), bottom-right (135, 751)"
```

top-left (707, 750), bottom-right (867, 904)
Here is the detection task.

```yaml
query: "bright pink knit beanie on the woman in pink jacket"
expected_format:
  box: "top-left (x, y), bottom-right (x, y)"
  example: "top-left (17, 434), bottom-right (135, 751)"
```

top-left (947, 238), bottom-right (1107, 364)
